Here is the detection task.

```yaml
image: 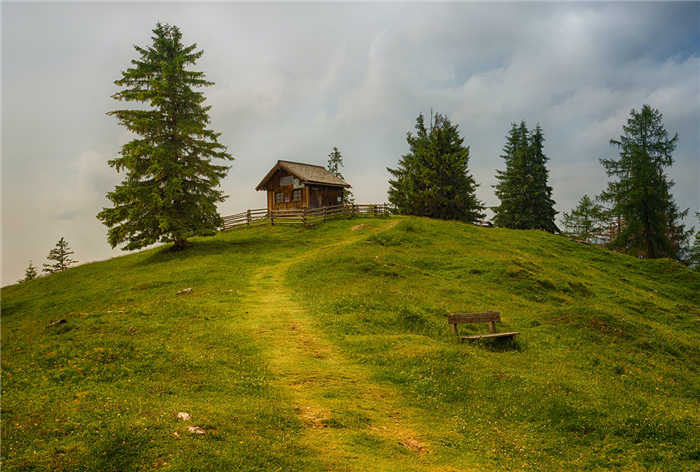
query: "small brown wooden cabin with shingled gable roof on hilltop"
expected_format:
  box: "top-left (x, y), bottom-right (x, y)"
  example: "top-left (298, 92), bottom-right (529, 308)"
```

top-left (255, 161), bottom-right (350, 210)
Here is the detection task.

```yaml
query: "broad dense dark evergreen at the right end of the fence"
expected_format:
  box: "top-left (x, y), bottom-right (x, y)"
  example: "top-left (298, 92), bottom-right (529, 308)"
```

top-left (387, 113), bottom-right (485, 223)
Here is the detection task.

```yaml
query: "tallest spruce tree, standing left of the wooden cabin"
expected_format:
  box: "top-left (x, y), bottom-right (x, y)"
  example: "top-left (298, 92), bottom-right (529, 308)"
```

top-left (97, 23), bottom-right (233, 250)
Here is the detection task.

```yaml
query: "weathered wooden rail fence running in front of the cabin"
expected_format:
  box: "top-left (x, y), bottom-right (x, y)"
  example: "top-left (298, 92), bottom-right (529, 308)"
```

top-left (221, 203), bottom-right (389, 231)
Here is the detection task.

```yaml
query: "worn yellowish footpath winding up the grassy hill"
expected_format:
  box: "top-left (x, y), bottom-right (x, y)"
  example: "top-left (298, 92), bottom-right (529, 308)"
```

top-left (237, 224), bottom-right (464, 471)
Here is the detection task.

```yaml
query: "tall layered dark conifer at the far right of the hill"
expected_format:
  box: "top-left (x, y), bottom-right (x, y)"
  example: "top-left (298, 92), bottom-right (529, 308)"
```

top-left (600, 105), bottom-right (691, 259)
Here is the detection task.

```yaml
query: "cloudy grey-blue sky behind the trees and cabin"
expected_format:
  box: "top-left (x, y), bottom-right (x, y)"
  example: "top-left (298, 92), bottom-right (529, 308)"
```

top-left (0, 0), bottom-right (700, 286)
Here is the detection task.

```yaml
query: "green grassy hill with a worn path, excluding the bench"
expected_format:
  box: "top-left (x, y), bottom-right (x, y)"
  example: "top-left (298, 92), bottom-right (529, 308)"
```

top-left (0, 217), bottom-right (700, 471)
